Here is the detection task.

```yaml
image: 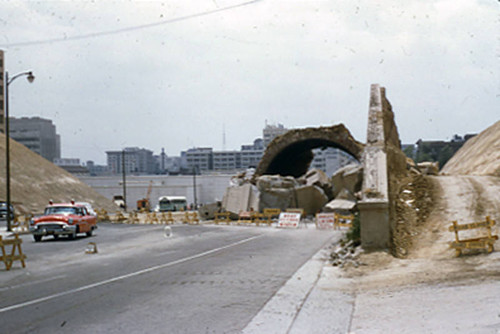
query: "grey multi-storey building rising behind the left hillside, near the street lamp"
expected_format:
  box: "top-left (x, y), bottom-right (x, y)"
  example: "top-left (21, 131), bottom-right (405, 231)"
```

top-left (9, 117), bottom-right (61, 162)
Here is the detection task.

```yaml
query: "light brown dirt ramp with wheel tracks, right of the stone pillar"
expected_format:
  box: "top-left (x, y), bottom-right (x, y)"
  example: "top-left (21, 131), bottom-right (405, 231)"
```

top-left (343, 176), bottom-right (500, 290)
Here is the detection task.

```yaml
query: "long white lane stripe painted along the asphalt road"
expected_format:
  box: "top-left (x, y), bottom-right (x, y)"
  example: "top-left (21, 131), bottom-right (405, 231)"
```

top-left (0, 235), bottom-right (262, 313)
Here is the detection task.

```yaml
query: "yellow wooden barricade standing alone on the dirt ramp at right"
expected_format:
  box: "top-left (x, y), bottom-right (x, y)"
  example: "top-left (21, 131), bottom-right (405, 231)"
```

top-left (448, 216), bottom-right (498, 256)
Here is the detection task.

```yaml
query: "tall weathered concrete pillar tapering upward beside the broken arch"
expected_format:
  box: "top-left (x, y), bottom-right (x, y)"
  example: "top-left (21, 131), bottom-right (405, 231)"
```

top-left (358, 84), bottom-right (407, 250)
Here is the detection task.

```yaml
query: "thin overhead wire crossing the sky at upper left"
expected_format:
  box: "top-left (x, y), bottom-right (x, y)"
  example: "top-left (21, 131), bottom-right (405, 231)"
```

top-left (0, 0), bottom-right (262, 48)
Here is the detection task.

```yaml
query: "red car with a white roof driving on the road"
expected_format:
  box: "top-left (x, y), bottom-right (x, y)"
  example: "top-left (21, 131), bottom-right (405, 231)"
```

top-left (30, 201), bottom-right (97, 241)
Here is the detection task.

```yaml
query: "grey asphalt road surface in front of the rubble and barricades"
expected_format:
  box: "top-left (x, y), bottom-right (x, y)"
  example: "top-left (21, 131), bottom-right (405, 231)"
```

top-left (0, 224), bottom-right (335, 333)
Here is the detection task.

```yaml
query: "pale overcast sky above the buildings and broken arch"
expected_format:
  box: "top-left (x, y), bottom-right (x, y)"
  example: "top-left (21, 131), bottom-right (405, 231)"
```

top-left (0, 0), bottom-right (500, 164)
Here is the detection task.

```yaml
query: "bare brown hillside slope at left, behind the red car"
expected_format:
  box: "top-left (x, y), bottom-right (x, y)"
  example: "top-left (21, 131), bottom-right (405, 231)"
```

top-left (0, 133), bottom-right (116, 214)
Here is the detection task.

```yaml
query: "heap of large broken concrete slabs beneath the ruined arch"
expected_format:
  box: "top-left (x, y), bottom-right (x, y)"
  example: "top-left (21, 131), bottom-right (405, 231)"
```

top-left (222, 165), bottom-right (363, 216)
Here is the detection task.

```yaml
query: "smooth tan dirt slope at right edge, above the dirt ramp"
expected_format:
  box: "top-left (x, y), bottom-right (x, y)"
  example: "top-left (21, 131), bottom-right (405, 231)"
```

top-left (441, 121), bottom-right (500, 176)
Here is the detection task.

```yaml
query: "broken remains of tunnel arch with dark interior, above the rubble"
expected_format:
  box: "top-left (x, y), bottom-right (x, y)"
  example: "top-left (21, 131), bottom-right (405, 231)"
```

top-left (255, 124), bottom-right (364, 177)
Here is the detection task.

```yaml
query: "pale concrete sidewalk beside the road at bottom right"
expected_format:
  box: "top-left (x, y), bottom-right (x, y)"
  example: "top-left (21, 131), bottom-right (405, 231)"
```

top-left (243, 236), bottom-right (500, 334)
